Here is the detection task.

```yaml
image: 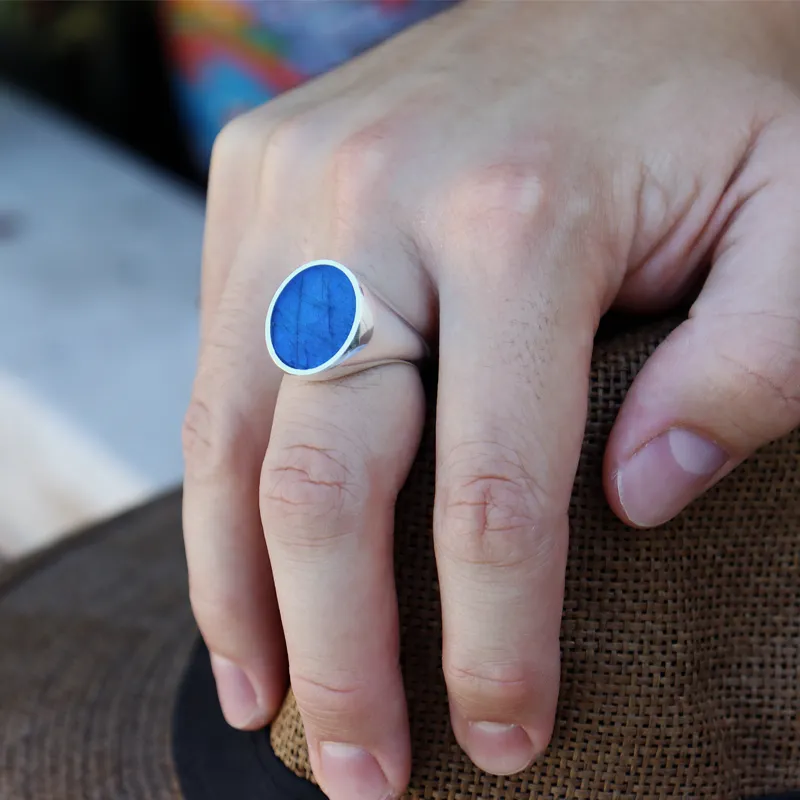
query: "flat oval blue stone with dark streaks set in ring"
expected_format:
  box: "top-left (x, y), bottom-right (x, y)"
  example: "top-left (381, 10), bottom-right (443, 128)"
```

top-left (269, 264), bottom-right (356, 370)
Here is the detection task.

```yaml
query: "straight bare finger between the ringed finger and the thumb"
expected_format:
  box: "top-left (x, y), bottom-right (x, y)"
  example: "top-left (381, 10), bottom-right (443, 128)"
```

top-left (435, 220), bottom-right (592, 774)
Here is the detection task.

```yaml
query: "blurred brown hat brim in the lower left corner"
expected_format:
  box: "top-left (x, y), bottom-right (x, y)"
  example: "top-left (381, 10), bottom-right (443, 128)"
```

top-left (0, 495), bottom-right (191, 800)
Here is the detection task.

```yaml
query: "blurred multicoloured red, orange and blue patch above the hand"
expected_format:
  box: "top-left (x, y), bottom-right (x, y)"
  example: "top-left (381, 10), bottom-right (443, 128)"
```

top-left (163, 0), bottom-right (455, 165)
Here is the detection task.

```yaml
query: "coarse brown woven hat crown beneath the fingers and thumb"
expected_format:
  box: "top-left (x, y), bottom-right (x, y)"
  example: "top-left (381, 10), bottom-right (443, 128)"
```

top-left (272, 318), bottom-right (800, 800)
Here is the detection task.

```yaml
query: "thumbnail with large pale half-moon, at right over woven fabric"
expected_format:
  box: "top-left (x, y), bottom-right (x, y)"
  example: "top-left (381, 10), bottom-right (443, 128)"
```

top-left (617, 428), bottom-right (729, 528)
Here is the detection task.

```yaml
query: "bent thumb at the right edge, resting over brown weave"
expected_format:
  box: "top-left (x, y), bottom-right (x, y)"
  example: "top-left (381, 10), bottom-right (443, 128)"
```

top-left (604, 112), bottom-right (800, 527)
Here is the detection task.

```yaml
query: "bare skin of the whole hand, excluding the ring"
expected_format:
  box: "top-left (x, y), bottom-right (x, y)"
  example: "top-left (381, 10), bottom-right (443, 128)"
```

top-left (184, 2), bottom-right (800, 800)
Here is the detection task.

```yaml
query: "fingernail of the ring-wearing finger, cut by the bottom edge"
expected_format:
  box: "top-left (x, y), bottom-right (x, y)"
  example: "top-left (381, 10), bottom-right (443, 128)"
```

top-left (320, 742), bottom-right (394, 800)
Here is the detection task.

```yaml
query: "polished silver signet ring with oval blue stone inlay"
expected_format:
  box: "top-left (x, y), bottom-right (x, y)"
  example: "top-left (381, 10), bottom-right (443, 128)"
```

top-left (265, 259), bottom-right (428, 380)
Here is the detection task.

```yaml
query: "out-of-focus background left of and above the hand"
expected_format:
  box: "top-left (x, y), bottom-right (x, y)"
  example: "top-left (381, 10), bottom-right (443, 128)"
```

top-left (0, 0), bottom-right (451, 564)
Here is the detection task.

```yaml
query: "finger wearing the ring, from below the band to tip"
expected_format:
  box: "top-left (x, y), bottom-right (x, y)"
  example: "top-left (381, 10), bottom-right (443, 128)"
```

top-left (261, 364), bottom-right (423, 800)
